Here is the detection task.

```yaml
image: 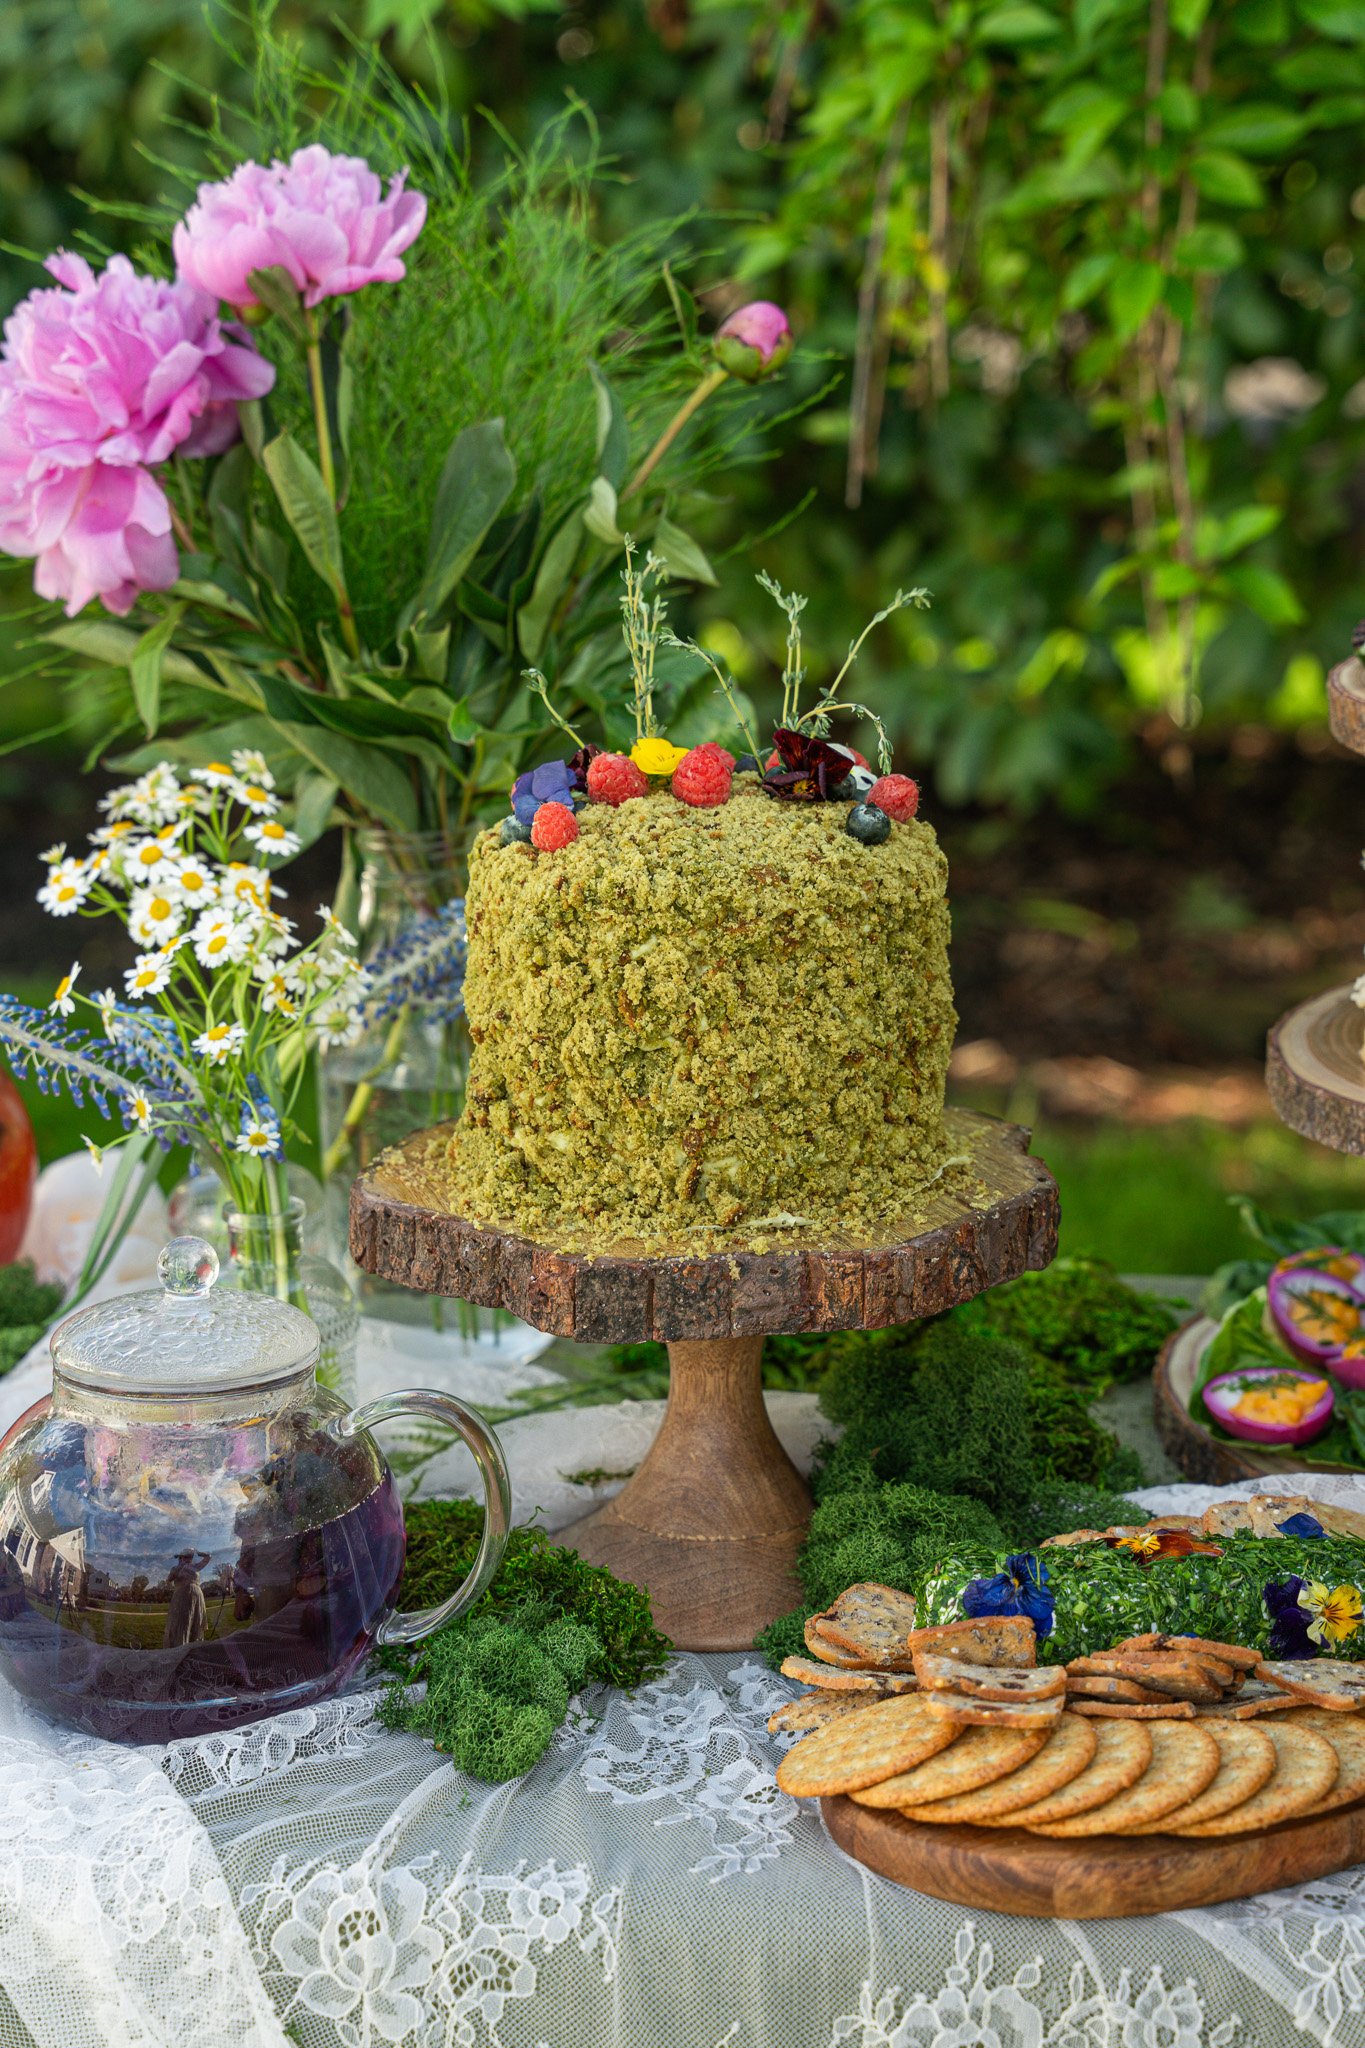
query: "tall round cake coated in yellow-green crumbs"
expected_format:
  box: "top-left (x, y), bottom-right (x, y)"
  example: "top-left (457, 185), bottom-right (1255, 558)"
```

top-left (450, 774), bottom-right (956, 1253)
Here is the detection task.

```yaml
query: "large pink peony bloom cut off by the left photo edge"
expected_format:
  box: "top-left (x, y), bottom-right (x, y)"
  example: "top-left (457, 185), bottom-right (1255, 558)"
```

top-left (0, 252), bottom-right (274, 614)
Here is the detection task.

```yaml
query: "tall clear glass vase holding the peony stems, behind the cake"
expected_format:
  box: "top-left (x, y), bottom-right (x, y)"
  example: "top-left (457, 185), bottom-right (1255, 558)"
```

top-left (317, 829), bottom-right (553, 1374)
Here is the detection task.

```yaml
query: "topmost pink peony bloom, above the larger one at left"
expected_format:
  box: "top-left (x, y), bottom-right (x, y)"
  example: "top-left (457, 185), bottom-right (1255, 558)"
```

top-left (174, 143), bottom-right (426, 307)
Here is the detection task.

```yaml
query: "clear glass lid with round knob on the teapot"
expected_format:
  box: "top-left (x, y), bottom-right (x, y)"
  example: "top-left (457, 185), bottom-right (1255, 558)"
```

top-left (51, 1237), bottom-right (319, 1399)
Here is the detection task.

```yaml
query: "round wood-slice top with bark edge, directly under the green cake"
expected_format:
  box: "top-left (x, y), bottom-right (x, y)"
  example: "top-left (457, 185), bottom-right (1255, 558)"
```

top-left (350, 1110), bottom-right (1058, 1343)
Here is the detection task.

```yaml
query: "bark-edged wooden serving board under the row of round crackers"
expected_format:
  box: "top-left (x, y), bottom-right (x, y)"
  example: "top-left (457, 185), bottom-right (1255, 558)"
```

top-left (821, 1796), bottom-right (1365, 1919)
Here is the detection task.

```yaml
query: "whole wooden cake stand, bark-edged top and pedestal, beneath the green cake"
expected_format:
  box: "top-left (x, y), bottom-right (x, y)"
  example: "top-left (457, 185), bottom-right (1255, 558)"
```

top-left (350, 1110), bottom-right (1058, 1651)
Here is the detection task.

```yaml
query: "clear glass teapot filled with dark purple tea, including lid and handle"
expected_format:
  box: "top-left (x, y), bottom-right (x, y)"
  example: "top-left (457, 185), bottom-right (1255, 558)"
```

top-left (0, 1237), bottom-right (510, 1743)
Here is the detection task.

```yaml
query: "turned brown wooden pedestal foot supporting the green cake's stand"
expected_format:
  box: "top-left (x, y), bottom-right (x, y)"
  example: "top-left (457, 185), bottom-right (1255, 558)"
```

top-left (559, 1337), bottom-right (810, 1651)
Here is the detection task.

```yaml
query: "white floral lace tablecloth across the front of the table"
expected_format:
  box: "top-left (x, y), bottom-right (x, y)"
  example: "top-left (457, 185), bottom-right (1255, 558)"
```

top-left (0, 1481), bottom-right (1365, 2048)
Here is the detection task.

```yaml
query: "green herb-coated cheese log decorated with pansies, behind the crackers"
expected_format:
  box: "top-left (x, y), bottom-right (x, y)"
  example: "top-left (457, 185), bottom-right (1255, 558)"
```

top-left (917, 1532), bottom-right (1365, 1663)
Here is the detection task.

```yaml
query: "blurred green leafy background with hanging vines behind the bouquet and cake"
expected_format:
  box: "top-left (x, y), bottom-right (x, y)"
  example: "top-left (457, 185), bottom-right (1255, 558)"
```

top-left (0, 0), bottom-right (1365, 809)
